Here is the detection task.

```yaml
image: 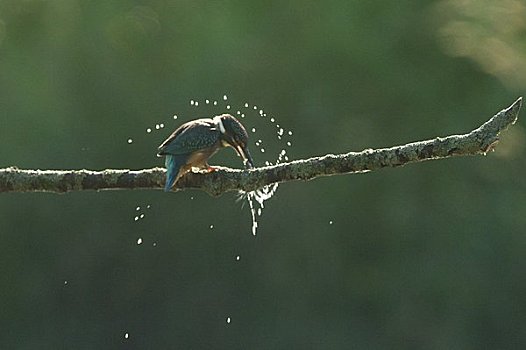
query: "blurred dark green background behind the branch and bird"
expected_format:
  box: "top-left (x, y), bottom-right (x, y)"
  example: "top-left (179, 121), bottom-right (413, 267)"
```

top-left (0, 0), bottom-right (526, 349)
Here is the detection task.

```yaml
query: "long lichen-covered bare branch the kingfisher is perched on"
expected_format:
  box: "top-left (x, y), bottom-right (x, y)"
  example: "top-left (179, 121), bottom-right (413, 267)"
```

top-left (0, 98), bottom-right (522, 196)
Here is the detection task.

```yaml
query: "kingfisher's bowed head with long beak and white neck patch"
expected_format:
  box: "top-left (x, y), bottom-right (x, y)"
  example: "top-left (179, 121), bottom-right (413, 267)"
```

top-left (214, 114), bottom-right (254, 168)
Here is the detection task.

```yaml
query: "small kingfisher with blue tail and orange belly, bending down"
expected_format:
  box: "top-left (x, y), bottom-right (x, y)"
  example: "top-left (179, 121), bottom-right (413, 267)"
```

top-left (157, 114), bottom-right (254, 192)
